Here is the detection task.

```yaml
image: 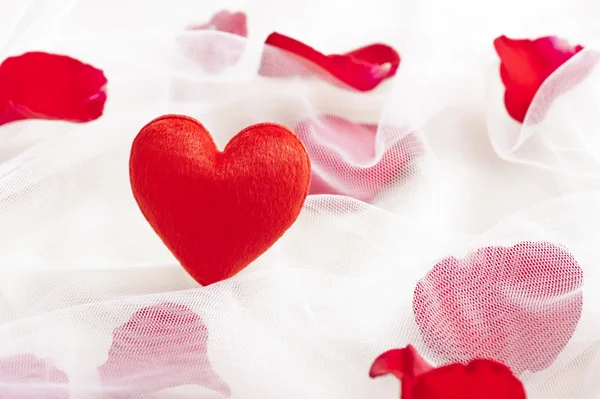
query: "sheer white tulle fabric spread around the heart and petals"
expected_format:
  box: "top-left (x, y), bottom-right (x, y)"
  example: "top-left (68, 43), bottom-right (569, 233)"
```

top-left (0, 0), bottom-right (600, 399)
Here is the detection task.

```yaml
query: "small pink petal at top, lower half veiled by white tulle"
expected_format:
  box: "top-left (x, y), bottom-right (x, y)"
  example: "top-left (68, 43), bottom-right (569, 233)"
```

top-left (181, 10), bottom-right (248, 74)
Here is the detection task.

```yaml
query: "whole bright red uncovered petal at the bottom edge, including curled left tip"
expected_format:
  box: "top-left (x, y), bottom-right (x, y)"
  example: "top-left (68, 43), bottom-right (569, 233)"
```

top-left (370, 345), bottom-right (526, 399)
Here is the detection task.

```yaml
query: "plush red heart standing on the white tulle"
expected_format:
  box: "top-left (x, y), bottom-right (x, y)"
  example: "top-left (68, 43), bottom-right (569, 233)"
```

top-left (129, 115), bottom-right (310, 285)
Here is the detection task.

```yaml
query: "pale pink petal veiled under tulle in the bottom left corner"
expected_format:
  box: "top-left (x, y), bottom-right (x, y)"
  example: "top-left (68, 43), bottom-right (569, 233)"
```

top-left (0, 353), bottom-right (69, 399)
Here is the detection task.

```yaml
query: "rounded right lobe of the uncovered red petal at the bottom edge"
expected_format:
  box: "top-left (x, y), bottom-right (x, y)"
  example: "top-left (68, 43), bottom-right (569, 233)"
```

top-left (412, 359), bottom-right (526, 399)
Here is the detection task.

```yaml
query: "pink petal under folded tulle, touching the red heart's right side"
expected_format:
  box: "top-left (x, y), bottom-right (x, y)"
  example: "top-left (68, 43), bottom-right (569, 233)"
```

top-left (295, 115), bottom-right (422, 202)
